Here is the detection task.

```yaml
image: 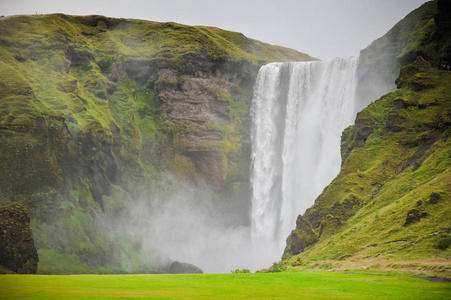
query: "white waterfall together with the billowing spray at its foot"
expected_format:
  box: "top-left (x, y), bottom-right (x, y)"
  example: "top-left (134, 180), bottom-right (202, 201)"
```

top-left (122, 58), bottom-right (370, 273)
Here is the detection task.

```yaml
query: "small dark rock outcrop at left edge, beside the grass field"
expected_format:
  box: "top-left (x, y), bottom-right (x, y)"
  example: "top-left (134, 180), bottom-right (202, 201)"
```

top-left (0, 204), bottom-right (39, 274)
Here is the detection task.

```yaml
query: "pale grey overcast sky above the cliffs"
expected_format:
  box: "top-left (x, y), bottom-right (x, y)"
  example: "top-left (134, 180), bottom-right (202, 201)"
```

top-left (0, 0), bottom-right (426, 59)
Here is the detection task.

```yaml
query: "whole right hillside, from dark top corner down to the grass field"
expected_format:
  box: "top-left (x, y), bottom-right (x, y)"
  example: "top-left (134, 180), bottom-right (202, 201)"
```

top-left (282, 1), bottom-right (451, 277)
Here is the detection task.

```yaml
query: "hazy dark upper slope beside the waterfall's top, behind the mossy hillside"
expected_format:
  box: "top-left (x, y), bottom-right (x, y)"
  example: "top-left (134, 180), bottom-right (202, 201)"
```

top-left (357, 1), bottom-right (451, 111)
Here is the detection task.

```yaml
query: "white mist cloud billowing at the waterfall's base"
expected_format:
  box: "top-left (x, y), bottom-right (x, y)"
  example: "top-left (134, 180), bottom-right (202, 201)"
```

top-left (106, 176), bottom-right (283, 273)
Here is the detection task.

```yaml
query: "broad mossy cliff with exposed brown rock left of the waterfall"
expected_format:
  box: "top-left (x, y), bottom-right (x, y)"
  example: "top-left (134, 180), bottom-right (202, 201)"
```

top-left (0, 14), bottom-right (313, 272)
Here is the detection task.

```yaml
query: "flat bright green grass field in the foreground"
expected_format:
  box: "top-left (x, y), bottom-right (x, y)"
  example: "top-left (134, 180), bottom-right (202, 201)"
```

top-left (0, 272), bottom-right (451, 299)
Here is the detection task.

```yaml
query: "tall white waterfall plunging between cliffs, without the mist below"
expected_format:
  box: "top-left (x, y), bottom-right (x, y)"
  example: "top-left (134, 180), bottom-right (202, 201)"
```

top-left (251, 58), bottom-right (358, 248)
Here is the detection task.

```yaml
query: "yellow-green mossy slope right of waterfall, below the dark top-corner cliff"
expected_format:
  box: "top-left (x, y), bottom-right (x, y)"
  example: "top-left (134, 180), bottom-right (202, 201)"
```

top-left (286, 63), bottom-right (451, 270)
